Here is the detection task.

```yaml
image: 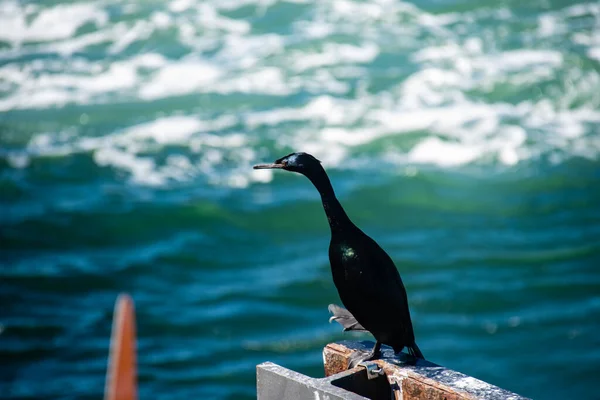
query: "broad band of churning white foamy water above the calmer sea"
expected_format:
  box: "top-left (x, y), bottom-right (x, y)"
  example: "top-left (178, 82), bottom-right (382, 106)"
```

top-left (0, 0), bottom-right (600, 188)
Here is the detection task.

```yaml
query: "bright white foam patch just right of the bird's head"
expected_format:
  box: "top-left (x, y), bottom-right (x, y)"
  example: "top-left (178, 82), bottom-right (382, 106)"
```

top-left (296, 100), bottom-right (526, 167)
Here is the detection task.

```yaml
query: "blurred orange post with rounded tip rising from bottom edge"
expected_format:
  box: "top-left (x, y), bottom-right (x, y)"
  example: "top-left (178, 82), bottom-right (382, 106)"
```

top-left (104, 294), bottom-right (138, 400)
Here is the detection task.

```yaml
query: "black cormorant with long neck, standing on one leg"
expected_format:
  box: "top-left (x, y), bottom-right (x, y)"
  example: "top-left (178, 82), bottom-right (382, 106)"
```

top-left (254, 153), bottom-right (424, 358)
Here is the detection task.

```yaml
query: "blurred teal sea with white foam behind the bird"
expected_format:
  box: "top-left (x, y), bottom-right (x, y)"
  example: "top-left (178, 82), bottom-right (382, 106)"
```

top-left (0, 0), bottom-right (600, 399)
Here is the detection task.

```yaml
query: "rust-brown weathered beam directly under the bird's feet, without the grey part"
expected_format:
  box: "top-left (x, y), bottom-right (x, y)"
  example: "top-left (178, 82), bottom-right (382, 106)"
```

top-left (323, 341), bottom-right (525, 400)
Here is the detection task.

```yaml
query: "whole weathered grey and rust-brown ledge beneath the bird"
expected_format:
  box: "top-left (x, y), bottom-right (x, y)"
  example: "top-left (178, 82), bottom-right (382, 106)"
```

top-left (256, 341), bottom-right (525, 400)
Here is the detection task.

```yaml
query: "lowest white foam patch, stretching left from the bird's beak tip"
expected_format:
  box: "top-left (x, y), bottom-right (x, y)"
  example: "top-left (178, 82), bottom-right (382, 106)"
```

top-left (20, 116), bottom-right (258, 187)
